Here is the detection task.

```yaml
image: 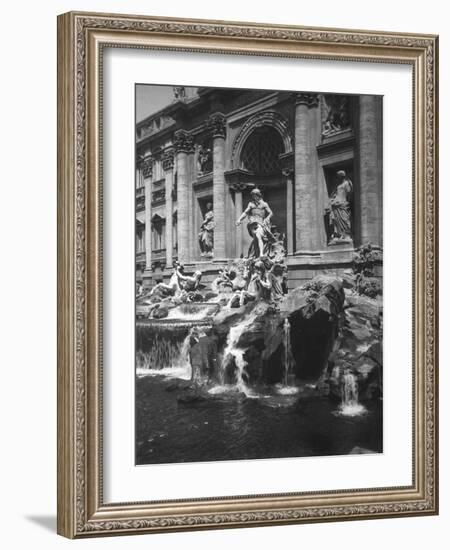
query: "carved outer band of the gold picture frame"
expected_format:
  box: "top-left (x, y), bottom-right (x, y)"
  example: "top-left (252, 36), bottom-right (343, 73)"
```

top-left (55, 14), bottom-right (437, 536)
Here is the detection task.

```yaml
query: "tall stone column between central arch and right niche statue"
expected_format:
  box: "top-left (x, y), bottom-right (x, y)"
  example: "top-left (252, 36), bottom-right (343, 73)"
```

top-left (294, 93), bottom-right (319, 254)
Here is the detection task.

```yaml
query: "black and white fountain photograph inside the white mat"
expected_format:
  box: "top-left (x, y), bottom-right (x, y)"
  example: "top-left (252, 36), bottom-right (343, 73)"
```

top-left (135, 83), bottom-right (383, 465)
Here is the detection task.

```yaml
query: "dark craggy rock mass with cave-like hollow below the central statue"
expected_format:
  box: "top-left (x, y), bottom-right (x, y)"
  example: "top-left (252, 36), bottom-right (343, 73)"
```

top-left (213, 276), bottom-right (345, 383)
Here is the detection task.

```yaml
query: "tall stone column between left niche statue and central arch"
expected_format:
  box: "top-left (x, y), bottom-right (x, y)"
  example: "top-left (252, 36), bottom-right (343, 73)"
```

top-left (208, 113), bottom-right (226, 260)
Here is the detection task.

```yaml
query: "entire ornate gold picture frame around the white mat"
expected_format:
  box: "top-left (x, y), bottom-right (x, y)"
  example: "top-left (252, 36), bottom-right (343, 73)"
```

top-left (58, 12), bottom-right (438, 538)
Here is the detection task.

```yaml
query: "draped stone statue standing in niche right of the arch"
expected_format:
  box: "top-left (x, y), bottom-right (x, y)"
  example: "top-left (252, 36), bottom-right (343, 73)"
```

top-left (325, 170), bottom-right (353, 244)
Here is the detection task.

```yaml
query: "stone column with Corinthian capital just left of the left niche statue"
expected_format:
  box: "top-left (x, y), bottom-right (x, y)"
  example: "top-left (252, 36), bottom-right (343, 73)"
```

top-left (174, 130), bottom-right (194, 264)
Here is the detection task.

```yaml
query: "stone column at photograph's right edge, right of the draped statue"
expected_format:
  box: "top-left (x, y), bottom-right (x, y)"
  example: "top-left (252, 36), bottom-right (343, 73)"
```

top-left (358, 95), bottom-right (382, 246)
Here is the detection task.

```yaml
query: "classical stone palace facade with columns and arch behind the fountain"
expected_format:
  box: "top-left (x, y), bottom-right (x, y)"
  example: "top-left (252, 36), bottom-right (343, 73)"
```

top-left (136, 88), bottom-right (383, 288)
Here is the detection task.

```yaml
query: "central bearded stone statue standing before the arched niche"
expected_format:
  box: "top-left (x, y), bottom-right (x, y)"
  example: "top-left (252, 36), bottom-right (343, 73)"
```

top-left (236, 189), bottom-right (275, 258)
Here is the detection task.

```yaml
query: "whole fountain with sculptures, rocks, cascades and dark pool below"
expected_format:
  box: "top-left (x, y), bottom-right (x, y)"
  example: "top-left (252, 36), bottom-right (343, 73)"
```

top-left (136, 190), bottom-right (382, 464)
